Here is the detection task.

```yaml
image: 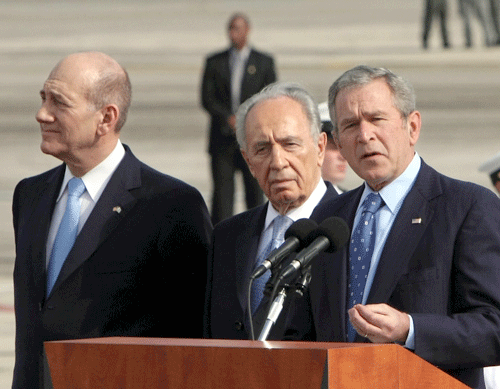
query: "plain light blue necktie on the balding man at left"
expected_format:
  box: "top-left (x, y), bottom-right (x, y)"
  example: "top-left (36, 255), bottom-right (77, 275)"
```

top-left (47, 177), bottom-right (85, 296)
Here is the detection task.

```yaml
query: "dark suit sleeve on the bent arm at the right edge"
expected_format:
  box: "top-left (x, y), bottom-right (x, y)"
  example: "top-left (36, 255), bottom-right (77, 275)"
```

top-left (408, 189), bottom-right (500, 369)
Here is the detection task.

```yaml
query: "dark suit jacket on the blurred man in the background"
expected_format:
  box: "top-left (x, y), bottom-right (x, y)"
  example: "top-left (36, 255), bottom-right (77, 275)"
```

top-left (201, 49), bottom-right (276, 154)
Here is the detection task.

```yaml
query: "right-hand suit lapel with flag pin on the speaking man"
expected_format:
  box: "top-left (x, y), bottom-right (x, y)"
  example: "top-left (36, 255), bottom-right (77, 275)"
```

top-left (367, 161), bottom-right (441, 304)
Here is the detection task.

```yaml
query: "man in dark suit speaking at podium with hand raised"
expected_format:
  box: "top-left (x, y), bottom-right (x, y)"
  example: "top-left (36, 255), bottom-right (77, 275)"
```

top-left (287, 66), bottom-right (500, 388)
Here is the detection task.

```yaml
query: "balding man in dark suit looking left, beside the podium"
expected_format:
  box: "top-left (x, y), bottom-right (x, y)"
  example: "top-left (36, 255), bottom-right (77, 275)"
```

top-left (12, 52), bottom-right (212, 388)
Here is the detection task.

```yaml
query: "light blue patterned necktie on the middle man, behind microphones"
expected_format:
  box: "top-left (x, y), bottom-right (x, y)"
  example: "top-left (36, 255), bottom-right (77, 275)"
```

top-left (251, 215), bottom-right (293, 313)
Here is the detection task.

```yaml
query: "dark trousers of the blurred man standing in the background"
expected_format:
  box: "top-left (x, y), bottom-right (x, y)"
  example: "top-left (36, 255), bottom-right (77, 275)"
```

top-left (211, 145), bottom-right (264, 225)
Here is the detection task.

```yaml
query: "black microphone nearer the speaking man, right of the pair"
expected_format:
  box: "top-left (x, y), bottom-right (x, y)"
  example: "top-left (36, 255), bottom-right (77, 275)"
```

top-left (280, 217), bottom-right (350, 279)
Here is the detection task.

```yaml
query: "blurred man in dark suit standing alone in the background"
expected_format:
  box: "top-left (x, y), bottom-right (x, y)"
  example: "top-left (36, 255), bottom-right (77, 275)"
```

top-left (201, 14), bottom-right (276, 225)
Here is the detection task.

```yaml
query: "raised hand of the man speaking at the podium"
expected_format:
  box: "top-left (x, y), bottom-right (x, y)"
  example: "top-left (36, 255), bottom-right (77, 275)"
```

top-left (349, 304), bottom-right (410, 343)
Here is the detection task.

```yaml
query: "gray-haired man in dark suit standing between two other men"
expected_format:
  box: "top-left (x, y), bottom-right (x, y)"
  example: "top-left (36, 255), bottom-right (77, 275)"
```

top-left (204, 83), bottom-right (337, 339)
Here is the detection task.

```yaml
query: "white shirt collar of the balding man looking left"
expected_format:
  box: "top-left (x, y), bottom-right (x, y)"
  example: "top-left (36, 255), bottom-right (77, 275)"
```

top-left (57, 139), bottom-right (125, 201)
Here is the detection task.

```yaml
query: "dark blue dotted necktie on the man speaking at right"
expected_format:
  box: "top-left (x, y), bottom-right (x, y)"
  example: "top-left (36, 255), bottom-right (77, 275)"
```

top-left (347, 193), bottom-right (382, 342)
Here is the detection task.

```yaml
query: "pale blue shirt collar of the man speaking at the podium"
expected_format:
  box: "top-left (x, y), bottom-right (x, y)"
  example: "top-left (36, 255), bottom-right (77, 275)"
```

top-left (359, 152), bottom-right (421, 213)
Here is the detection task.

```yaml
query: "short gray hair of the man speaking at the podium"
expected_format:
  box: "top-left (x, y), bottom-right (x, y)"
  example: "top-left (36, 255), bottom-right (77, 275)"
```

top-left (328, 65), bottom-right (416, 137)
